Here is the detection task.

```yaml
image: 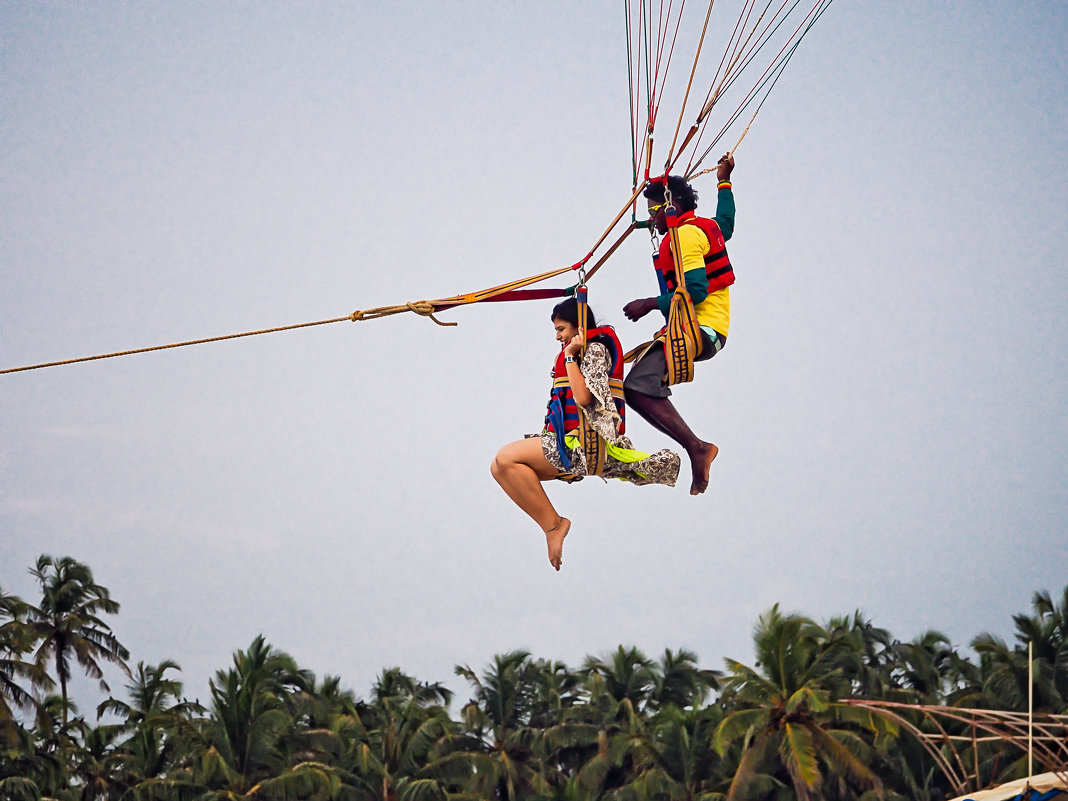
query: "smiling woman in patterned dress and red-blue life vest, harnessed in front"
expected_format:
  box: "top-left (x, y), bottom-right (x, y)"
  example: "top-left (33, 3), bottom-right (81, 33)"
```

top-left (490, 298), bottom-right (679, 570)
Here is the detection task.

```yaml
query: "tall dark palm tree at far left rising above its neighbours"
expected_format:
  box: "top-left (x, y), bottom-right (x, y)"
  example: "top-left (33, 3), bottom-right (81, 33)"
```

top-left (26, 555), bottom-right (129, 723)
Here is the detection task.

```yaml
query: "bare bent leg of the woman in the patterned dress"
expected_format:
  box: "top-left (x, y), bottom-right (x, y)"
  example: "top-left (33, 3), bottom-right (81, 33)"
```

top-left (489, 437), bottom-right (571, 570)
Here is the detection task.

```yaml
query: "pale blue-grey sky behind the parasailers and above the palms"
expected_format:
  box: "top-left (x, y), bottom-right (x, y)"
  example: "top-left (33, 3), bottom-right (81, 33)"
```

top-left (0, 0), bottom-right (1068, 713)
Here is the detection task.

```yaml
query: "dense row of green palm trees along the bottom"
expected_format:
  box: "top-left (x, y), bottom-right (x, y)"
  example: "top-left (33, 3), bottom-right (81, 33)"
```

top-left (0, 556), bottom-right (1068, 801)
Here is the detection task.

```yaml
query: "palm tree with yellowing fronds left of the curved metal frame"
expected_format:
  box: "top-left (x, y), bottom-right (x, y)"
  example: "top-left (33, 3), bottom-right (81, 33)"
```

top-left (716, 604), bottom-right (890, 801)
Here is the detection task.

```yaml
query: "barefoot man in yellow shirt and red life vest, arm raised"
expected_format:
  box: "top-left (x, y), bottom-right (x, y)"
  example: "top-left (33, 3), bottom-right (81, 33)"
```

top-left (623, 154), bottom-right (735, 496)
